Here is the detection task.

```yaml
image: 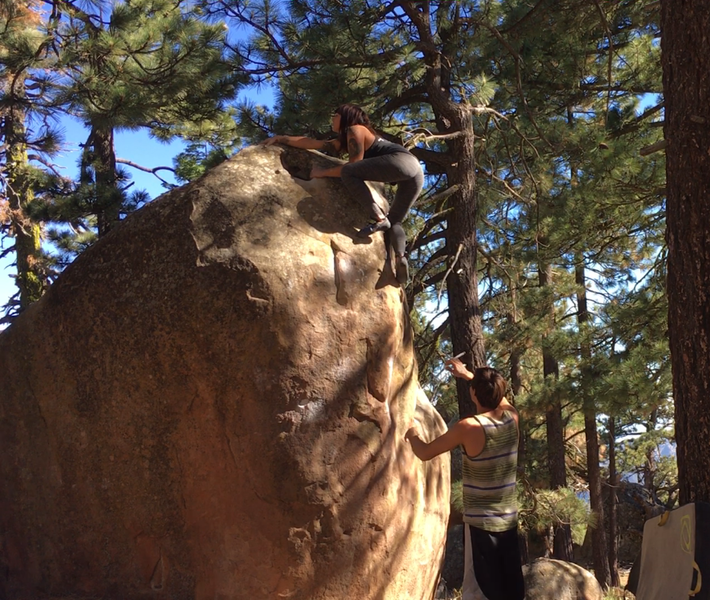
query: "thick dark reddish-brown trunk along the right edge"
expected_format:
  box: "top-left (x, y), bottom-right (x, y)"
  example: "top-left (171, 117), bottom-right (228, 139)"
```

top-left (661, 0), bottom-right (710, 504)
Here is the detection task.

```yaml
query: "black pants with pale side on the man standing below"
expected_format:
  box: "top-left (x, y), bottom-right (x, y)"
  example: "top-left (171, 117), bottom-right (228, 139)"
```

top-left (466, 525), bottom-right (525, 600)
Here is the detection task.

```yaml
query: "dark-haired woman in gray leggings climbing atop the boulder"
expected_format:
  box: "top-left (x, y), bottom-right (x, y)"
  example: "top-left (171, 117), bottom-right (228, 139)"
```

top-left (263, 104), bottom-right (424, 285)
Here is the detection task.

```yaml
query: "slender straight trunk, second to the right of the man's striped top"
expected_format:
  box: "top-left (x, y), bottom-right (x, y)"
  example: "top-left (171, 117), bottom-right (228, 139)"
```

top-left (575, 263), bottom-right (611, 589)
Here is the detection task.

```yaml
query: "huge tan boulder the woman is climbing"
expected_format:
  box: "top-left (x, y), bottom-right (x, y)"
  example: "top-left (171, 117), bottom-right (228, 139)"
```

top-left (0, 146), bottom-right (449, 600)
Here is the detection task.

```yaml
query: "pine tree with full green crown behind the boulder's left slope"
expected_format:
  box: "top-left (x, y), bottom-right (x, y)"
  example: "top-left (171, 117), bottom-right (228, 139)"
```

top-left (48, 0), bottom-right (239, 236)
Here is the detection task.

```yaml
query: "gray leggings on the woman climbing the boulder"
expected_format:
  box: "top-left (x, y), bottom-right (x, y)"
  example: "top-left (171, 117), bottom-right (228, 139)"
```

top-left (340, 152), bottom-right (424, 256)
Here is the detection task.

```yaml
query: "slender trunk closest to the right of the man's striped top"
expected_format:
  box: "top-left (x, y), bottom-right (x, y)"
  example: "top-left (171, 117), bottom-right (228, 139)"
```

top-left (539, 264), bottom-right (573, 562)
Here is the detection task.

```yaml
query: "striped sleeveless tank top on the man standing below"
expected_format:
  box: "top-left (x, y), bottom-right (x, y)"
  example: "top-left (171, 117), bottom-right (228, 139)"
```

top-left (462, 410), bottom-right (518, 532)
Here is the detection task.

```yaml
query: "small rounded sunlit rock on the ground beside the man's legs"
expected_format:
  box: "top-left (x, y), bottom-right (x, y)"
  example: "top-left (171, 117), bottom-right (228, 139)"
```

top-left (523, 558), bottom-right (603, 600)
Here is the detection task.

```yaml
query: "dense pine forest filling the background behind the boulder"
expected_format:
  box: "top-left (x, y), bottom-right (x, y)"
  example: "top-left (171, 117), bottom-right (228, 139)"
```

top-left (0, 0), bottom-right (679, 585)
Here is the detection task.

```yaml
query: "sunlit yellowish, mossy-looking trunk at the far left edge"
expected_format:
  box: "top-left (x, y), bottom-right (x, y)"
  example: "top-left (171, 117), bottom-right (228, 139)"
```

top-left (2, 75), bottom-right (44, 312)
